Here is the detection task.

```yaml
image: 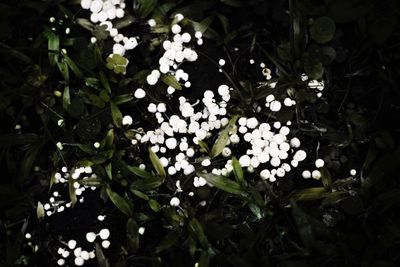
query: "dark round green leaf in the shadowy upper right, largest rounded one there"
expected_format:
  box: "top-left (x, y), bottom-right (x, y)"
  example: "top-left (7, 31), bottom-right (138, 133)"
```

top-left (310, 16), bottom-right (336, 44)
